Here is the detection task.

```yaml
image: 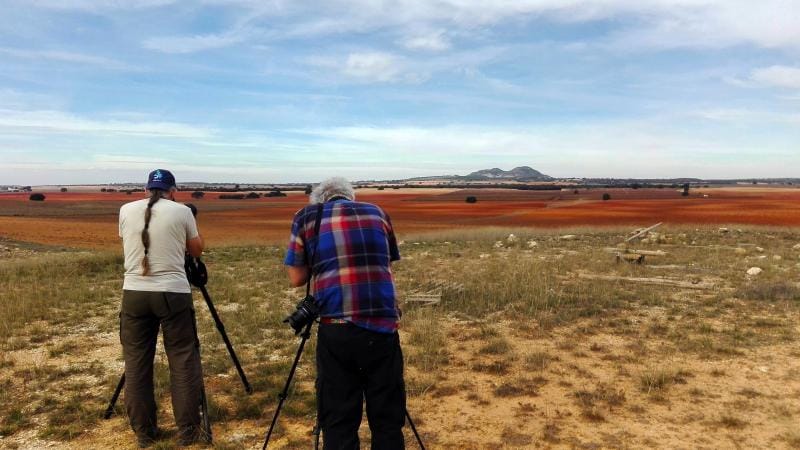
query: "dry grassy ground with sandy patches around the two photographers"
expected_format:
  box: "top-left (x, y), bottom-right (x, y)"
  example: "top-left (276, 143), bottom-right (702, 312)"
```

top-left (0, 227), bottom-right (800, 448)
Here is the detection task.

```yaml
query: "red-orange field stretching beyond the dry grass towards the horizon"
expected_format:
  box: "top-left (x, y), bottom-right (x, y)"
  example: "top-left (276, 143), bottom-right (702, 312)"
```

top-left (0, 187), bottom-right (800, 249)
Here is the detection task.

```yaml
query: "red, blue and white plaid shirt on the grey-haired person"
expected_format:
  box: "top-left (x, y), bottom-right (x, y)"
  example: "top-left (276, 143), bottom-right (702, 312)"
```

top-left (284, 200), bottom-right (400, 333)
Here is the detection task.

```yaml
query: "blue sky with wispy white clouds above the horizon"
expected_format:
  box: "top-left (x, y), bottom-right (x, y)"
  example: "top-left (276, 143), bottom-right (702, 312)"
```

top-left (0, 0), bottom-right (800, 184)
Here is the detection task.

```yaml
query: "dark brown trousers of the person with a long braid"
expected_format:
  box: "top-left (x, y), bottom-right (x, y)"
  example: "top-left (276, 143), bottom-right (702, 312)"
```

top-left (119, 290), bottom-right (203, 437)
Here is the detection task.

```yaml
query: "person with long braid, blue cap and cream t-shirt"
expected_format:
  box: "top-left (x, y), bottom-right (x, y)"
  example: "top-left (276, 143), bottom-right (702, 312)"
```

top-left (119, 169), bottom-right (208, 448)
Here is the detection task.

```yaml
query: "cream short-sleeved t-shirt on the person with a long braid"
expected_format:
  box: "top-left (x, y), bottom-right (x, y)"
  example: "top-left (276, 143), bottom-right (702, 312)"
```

top-left (119, 198), bottom-right (198, 293)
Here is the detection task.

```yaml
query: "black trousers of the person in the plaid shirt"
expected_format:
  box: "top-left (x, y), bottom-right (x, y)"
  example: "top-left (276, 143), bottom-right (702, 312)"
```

top-left (317, 324), bottom-right (406, 450)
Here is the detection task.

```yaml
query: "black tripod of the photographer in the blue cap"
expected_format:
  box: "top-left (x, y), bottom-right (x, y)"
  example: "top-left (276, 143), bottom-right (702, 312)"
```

top-left (103, 255), bottom-right (253, 442)
